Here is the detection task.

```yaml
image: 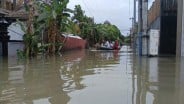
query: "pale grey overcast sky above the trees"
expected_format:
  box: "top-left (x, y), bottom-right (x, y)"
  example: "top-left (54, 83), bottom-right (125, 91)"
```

top-left (68, 0), bottom-right (133, 35)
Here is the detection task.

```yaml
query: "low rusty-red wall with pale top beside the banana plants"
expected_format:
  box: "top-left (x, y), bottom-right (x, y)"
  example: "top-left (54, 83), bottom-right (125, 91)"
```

top-left (60, 34), bottom-right (87, 51)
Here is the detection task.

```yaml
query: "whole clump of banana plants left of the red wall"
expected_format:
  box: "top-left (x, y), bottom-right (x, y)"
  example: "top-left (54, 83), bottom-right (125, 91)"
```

top-left (17, 0), bottom-right (72, 56)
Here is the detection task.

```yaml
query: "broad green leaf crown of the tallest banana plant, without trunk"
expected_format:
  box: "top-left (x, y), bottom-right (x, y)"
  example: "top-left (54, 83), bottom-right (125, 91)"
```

top-left (36, 0), bottom-right (72, 30)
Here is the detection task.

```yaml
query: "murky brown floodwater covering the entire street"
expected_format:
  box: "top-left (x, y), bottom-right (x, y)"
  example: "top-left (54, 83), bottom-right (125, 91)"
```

top-left (0, 43), bottom-right (184, 104)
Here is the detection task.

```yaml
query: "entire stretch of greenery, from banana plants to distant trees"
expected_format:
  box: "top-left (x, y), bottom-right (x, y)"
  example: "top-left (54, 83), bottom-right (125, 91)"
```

top-left (19, 0), bottom-right (122, 57)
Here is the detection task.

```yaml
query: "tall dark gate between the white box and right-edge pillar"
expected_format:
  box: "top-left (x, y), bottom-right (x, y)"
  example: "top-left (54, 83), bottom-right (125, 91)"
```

top-left (159, 0), bottom-right (177, 55)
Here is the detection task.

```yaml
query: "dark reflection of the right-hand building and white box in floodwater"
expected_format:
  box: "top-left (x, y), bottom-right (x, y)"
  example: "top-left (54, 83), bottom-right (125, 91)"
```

top-left (134, 57), bottom-right (184, 104)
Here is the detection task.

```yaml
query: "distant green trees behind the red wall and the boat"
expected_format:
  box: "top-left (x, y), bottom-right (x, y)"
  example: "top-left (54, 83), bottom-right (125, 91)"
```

top-left (72, 5), bottom-right (121, 46)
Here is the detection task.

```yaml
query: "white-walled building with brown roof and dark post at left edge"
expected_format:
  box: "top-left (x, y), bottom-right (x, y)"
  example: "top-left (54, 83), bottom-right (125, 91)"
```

top-left (0, 0), bottom-right (28, 56)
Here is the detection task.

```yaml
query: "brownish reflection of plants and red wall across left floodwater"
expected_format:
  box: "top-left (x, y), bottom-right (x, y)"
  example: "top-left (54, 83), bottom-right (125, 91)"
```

top-left (0, 50), bottom-right (120, 104)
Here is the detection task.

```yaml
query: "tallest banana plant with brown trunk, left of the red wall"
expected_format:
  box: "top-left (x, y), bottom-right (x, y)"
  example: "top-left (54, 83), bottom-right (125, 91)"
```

top-left (34, 0), bottom-right (72, 54)
